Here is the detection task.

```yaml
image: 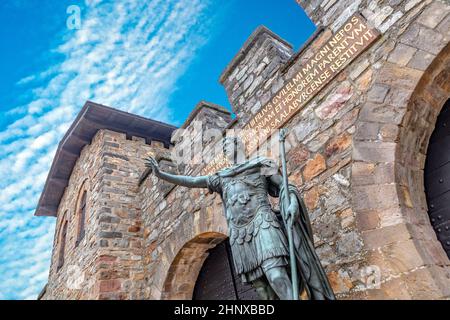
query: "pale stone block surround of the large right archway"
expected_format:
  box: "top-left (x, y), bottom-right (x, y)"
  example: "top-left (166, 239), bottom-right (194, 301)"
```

top-left (351, 39), bottom-right (450, 299)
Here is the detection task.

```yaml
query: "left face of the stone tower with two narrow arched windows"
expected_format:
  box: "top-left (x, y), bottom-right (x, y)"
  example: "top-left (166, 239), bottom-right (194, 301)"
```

top-left (43, 129), bottom-right (103, 299)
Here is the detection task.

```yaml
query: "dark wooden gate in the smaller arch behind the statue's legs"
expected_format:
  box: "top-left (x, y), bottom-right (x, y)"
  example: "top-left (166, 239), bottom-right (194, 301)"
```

top-left (193, 240), bottom-right (258, 300)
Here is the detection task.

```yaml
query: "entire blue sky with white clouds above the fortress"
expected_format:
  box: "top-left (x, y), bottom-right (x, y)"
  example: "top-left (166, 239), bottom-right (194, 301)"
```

top-left (0, 0), bottom-right (315, 299)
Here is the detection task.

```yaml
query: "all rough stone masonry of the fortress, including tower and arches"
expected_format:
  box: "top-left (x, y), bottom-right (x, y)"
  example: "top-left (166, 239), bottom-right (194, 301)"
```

top-left (40, 0), bottom-right (450, 299)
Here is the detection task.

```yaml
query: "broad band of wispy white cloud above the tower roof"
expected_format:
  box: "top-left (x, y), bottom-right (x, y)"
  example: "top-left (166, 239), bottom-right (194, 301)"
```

top-left (0, 0), bottom-right (217, 299)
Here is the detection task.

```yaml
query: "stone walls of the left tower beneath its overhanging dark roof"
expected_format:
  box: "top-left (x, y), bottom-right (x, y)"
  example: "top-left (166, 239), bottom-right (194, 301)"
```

top-left (44, 130), bottom-right (156, 299)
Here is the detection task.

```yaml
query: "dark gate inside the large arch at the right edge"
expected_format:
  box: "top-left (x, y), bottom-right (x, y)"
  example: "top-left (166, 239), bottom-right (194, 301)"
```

top-left (425, 100), bottom-right (450, 258)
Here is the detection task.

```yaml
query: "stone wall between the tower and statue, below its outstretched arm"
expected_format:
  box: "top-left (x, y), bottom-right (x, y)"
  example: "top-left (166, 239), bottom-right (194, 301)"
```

top-left (140, 102), bottom-right (231, 299)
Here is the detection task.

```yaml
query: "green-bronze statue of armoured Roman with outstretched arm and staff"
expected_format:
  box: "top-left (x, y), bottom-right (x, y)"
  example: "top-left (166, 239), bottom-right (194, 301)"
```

top-left (146, 131), bottom-right (335, 300)
